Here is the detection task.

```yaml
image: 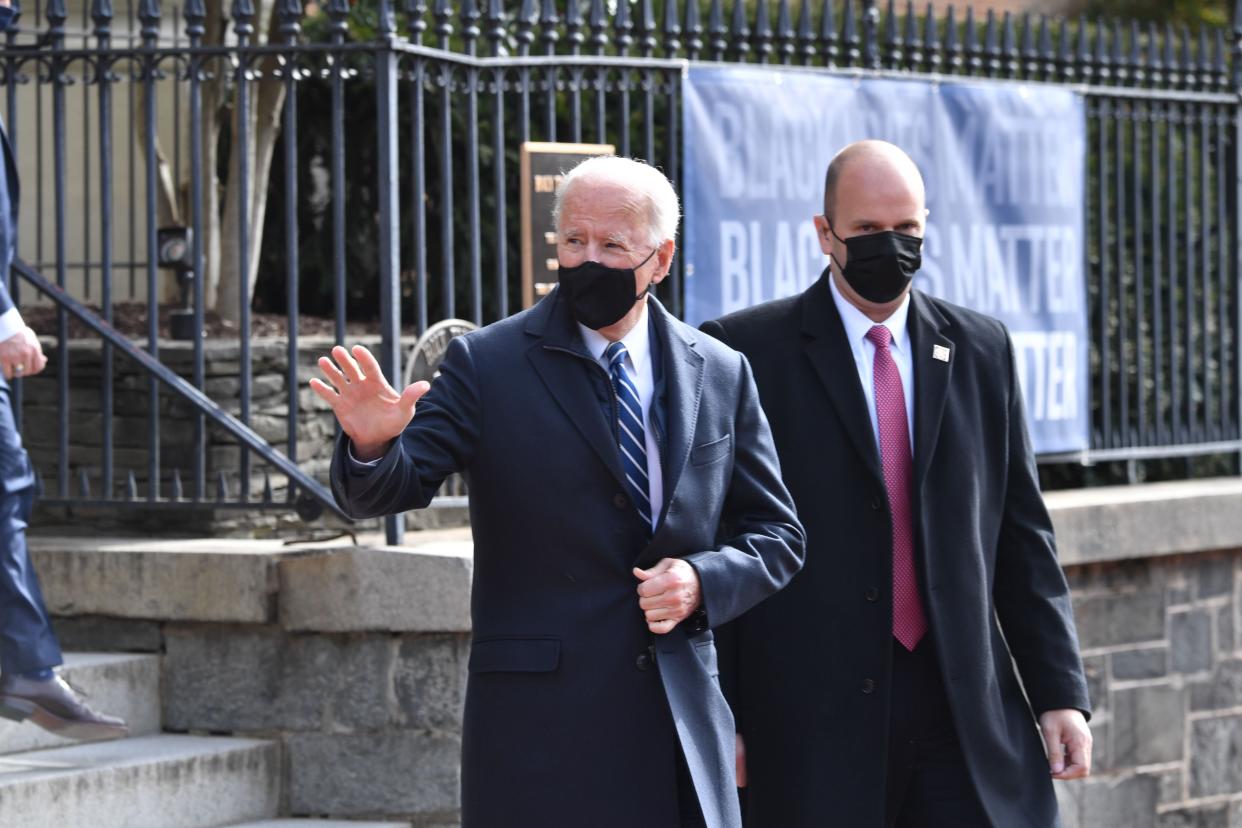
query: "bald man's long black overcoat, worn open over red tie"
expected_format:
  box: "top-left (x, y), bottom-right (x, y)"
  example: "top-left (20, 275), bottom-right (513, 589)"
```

top-left (704, 272), bottom-right (1089, 828)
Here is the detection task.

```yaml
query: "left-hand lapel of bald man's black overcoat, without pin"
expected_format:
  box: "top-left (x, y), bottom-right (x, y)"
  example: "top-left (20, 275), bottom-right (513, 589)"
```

top-left (801, 271), bottom-right (884, 483)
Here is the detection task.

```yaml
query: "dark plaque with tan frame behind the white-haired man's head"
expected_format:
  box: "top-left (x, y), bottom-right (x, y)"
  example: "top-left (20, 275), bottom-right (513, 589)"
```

top-left (520, 142), bottom-right (615, 308)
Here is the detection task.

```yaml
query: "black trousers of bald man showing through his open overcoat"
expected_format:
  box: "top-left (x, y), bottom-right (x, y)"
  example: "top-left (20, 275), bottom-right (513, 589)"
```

top-left (886, 636), bottom-right (991, 828)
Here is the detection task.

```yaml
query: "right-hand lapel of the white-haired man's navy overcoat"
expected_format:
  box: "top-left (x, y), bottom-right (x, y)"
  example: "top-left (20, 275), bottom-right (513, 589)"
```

top-left (647, 297), bottom-right (703, 533)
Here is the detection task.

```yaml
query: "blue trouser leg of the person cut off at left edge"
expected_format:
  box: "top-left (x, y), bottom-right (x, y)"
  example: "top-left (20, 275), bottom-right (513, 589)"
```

top-left (0, 380), bottom-right (61, 674)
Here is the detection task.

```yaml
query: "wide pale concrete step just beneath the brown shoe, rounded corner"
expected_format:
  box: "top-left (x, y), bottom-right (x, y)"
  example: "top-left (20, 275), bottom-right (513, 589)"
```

top-left (0, 735), bottom-right (281, 828)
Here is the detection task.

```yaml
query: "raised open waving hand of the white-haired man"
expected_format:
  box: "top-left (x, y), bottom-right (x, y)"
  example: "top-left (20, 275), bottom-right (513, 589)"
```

top-left (311, 345), bottom-right (431, 461)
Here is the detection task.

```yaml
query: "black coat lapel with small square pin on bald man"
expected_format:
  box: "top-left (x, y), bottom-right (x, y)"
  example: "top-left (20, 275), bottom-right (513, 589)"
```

top-left (907, 290), bottom-right (956, 489)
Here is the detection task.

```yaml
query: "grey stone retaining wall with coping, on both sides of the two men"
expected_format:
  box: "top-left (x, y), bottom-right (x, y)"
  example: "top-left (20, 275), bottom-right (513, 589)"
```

top-left (35, 479), bottom-right (1242, 828)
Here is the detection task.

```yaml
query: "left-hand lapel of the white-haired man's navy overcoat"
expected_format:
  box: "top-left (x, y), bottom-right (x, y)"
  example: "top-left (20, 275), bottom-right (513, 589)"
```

top-left (527, 290), bottom-right (625, 490)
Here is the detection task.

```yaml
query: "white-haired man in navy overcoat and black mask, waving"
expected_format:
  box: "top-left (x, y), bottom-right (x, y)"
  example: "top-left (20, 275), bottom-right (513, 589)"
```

top-left (312, 156), bottom-right (804, 828)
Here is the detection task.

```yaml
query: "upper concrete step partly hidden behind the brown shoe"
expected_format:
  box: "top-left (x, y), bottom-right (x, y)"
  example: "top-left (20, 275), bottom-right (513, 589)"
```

top-left (0, 653), bottom-right (160, 755)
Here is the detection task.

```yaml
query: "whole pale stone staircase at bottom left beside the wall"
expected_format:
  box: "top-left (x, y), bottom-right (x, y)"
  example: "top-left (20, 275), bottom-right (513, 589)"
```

top-left (0, 654), bottom-right (409, 828)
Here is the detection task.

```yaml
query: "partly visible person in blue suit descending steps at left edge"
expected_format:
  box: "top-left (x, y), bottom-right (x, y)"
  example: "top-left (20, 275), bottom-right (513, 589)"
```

top-left (0, 0), bottom-right (127, 739)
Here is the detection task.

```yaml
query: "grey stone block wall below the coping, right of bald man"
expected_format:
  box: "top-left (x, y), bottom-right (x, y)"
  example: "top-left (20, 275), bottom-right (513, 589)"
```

top-left (1058, 550), bottom-right (1242, 828)
